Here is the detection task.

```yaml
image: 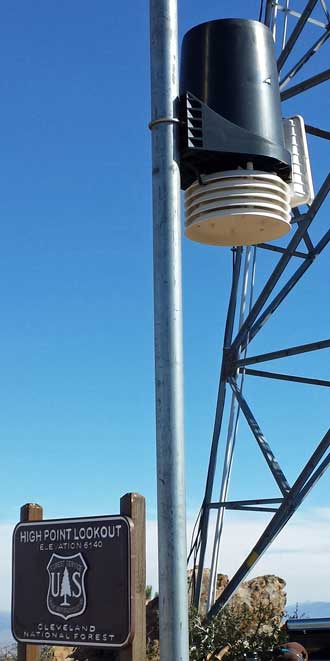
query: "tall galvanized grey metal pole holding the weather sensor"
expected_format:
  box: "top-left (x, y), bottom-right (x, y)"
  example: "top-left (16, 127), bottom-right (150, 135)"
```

top-left (150, 0), bottom-right (189, 661)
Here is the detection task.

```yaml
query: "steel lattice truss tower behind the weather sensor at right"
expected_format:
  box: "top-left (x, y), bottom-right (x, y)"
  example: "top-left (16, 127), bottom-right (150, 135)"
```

top-left (190, 0), bottom-right (330, 619)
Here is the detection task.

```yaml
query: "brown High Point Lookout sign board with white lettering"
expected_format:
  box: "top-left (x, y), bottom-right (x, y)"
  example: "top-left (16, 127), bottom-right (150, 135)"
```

top-left (12, 516), bottom-right (134, 648)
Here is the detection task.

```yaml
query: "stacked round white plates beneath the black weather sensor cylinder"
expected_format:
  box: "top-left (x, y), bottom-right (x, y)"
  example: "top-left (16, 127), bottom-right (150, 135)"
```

top-left (184, 169), bottom-right (291, 246)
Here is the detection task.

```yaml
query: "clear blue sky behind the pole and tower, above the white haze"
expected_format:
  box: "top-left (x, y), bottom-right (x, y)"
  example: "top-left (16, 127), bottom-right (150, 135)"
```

top-left (0, 0), bottom-right (330, 607)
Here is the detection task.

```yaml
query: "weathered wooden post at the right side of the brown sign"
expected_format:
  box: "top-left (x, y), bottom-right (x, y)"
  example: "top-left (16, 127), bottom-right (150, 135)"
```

top-left (118, 493), bottom-right (146, 661)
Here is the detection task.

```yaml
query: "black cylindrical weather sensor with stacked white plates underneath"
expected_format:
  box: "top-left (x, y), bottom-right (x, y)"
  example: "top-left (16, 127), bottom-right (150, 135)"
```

top-left (180, 19), bottom-right (291, 245)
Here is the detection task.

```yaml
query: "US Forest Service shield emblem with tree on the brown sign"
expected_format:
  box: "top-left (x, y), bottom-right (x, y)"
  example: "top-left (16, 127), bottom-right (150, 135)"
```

top-left (47, 553), bottom-right (87, 620)
